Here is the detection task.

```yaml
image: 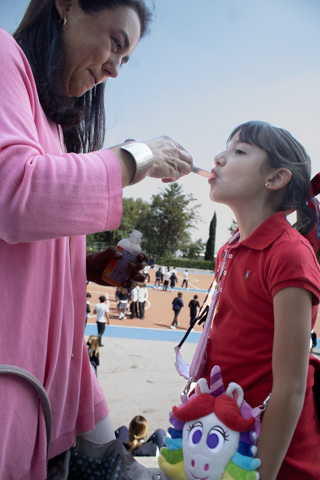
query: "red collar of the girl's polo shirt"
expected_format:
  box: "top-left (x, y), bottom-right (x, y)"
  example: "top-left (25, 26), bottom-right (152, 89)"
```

top-left (235, 212), bottom-right (292, 250)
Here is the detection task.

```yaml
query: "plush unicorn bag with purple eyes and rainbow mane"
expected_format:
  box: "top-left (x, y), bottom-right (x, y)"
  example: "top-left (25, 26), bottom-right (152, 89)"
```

top-left (159, 366), bottom-right (261, 480)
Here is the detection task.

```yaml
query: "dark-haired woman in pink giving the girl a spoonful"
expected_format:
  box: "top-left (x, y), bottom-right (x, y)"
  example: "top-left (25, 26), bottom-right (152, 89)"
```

top-left (0, 0), bottom-right (192, 480)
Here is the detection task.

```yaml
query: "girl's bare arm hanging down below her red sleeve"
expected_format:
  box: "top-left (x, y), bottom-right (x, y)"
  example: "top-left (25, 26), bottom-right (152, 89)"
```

top-left (257, 288), bottom-right (311, 480)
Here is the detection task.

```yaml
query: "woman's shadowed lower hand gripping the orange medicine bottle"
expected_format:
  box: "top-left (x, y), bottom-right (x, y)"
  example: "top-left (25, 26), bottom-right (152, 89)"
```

top-left (86, 247), bottom-right (146, 288)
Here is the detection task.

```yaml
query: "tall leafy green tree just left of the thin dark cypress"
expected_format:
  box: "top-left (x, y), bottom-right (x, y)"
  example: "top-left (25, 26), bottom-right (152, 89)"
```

top-left (137, 183), bottom-right (199, 256)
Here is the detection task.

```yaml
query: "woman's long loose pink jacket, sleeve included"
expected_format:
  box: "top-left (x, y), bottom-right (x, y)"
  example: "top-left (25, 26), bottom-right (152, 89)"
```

top-left (0, 30), bottom-right (122, 480)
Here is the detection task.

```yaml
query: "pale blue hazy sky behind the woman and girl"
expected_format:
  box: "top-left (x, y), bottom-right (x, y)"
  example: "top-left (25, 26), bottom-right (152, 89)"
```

top-left (0, 0), bottom-right (320, 248)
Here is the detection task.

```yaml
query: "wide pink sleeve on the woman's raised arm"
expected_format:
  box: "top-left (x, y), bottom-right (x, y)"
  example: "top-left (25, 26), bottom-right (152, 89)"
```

top-left (0, 29), bottom-right (122, 243)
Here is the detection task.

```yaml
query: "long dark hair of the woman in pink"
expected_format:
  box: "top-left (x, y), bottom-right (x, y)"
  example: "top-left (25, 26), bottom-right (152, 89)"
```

top-left (13, 0), bottom-right (151, 153)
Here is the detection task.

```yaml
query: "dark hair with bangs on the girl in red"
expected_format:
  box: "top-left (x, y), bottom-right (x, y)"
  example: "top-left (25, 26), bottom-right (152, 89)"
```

top-left (228, 121), bottom-right (316, 235)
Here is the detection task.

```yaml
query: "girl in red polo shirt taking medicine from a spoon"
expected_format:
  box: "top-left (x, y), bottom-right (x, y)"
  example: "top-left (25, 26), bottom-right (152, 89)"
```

top-left (205, 122), bottom-right (320, 480)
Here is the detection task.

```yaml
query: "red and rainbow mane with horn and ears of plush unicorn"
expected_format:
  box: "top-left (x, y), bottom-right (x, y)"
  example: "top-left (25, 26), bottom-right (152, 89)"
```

top-left (158, 366), bottom-right (261, 480)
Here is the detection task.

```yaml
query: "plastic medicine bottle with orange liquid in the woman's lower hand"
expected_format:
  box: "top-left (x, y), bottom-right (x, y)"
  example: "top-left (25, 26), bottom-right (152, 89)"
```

top-left (102, 230), bottom-right (142, 287)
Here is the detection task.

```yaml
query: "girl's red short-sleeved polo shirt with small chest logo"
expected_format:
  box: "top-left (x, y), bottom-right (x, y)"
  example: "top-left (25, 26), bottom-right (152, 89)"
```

top-left (205, 212), bottom-right (320, 480)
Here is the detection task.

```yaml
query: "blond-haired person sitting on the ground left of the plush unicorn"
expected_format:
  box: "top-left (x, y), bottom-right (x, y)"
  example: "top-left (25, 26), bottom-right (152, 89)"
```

top-left (115, 415), bottom-right (166, 457)
